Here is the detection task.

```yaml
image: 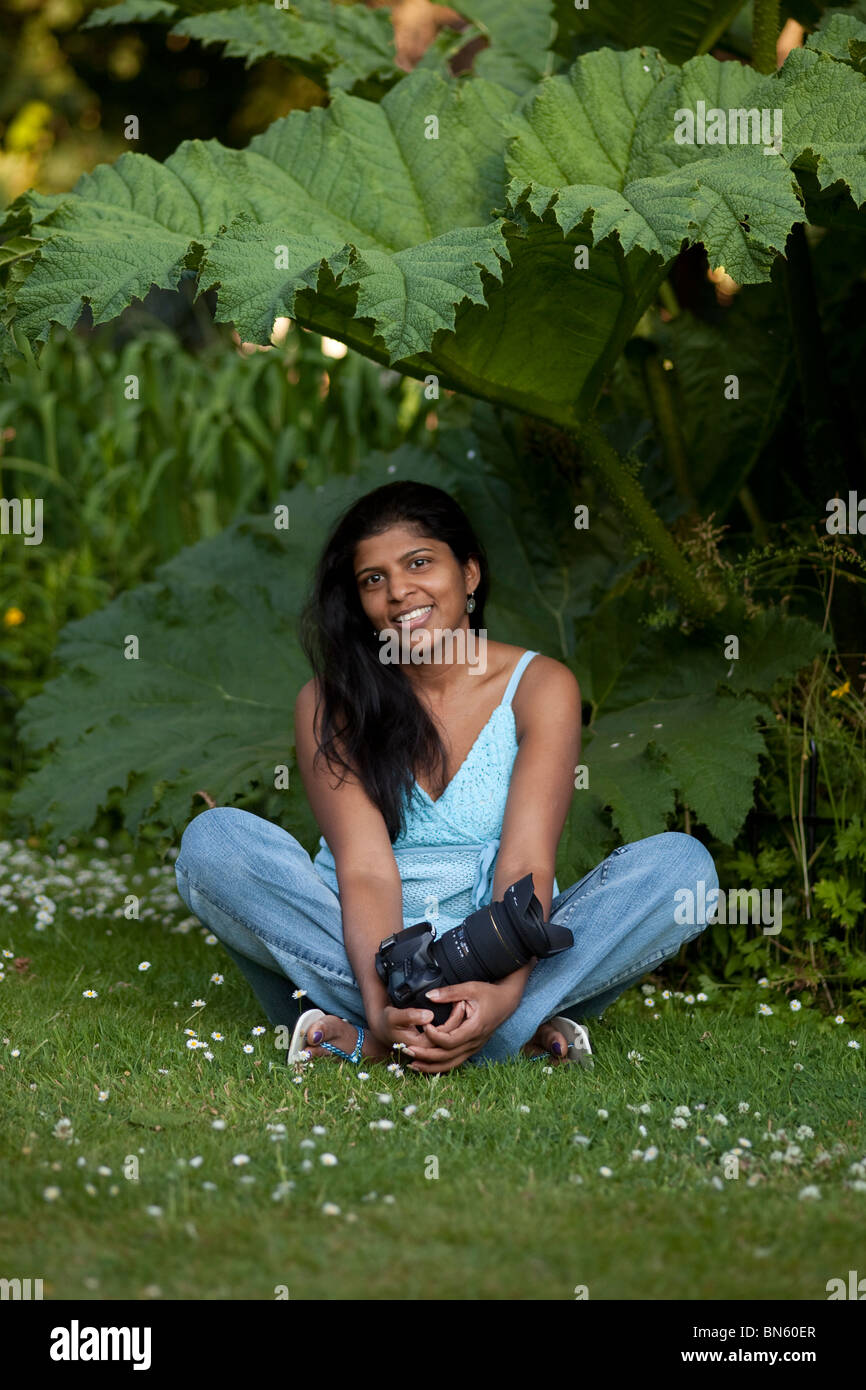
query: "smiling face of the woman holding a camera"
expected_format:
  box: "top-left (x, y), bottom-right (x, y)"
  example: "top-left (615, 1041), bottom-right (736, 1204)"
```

top-left (354, 523), bottom-right (481, 646)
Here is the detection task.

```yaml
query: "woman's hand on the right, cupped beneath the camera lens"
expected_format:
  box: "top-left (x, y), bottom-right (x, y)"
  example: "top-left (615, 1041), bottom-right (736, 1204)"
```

top-left (402, 979), bottom-right (523, 1072)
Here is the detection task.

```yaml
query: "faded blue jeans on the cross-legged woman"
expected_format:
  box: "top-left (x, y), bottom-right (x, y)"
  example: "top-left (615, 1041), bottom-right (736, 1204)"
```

top-left (175, 806), bottom-right (719, 1063)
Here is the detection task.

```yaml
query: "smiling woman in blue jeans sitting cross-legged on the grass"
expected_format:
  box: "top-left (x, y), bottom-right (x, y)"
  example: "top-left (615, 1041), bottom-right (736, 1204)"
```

top-left (175, 482), bottom-right (719, 1072)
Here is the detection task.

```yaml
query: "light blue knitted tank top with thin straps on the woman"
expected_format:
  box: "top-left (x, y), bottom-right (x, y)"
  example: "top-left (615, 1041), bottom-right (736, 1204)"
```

top-left (313, 652), bottom-right (559, 935)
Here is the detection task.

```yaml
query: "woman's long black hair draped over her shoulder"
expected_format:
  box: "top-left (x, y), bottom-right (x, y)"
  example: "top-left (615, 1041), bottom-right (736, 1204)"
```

top-left (300, 481), bottom-right (489, 841)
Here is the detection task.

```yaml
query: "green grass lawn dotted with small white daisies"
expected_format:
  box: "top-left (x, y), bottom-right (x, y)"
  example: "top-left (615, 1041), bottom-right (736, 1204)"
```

top-left (0, 841), bottom-right (866, 1300)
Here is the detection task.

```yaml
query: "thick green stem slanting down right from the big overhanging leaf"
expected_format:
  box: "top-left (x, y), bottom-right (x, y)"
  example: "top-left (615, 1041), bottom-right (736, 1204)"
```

top-left (574, 418), bottom-right (716, 619)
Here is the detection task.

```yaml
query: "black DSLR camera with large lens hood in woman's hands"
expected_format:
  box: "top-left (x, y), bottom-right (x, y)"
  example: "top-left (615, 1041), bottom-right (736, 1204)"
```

top-left (375, 873), bottom-right (574, 1026)
